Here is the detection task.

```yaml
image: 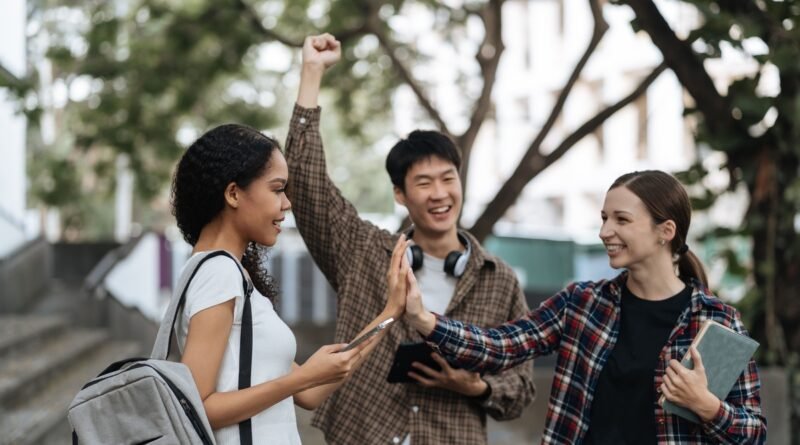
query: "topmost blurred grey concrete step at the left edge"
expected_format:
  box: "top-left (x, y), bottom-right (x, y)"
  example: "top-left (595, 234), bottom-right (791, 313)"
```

top-left (0, 314), bottom-right (67, 363)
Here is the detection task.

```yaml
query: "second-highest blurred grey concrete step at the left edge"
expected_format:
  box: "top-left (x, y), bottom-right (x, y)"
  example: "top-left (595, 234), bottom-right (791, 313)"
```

top-left (0, 329), bottom-right (108, 406)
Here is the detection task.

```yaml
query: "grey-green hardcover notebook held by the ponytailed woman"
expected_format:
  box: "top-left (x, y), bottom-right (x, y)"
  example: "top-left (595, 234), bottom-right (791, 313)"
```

top-left (660, 320), bottom-right (758, 423)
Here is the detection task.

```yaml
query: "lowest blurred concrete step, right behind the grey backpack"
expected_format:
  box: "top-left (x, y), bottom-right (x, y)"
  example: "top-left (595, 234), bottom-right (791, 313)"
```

top-left (0, 341), bottom-right (141, 445)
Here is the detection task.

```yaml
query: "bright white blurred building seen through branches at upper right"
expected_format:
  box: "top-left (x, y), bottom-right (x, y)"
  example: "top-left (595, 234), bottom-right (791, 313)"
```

top-left (390, 0), bottom-right (760, 299)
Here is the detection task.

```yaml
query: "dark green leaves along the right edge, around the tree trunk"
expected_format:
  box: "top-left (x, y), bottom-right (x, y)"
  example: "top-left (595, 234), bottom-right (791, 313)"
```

top-left (668, 0), bottom-right (800, 363)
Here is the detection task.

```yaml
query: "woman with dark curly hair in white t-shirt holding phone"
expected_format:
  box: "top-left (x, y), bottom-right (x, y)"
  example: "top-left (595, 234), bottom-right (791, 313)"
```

top-left (172, 99), bottom-right (406, 444)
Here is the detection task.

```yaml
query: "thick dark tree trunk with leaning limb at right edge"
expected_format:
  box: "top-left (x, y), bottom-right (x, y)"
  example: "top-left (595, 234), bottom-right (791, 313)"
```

top-left (625, 0), bottom-right (800, 364)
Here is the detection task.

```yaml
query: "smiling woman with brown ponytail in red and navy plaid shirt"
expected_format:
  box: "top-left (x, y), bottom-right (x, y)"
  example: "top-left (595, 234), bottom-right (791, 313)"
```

top-left (392, 171), bottom-right (766, 444)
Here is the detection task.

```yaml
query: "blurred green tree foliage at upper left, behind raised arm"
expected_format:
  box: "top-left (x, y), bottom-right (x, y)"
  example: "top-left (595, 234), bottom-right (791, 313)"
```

top-left (12, 0), bottom-right (424, 238)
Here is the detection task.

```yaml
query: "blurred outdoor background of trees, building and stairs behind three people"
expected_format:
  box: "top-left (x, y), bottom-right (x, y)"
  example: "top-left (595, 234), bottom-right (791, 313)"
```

top-left (0, 0), bottom-right (800, 445)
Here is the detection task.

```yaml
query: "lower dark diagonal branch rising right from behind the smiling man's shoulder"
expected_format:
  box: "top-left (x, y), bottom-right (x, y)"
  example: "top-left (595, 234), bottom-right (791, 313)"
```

top-left (470, 63), bottom-right (667, 240)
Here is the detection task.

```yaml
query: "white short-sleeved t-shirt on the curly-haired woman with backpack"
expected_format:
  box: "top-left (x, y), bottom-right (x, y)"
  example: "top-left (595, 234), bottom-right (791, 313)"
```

top-left (175, 256), bottom-right (300, 445)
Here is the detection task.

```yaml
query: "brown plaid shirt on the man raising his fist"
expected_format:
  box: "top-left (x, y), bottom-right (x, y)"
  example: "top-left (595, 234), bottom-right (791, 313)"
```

top-left (286, 105), bottom-right (535, 445)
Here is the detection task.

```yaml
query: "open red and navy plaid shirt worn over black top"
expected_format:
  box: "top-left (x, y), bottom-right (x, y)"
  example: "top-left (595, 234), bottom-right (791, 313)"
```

top-left (427, 273), bottom-right (767, 444)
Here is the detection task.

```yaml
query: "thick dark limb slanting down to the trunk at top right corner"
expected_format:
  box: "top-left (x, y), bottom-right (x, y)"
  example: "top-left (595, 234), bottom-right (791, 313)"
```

top-left (626, 0), bottom-right (736, 135)
